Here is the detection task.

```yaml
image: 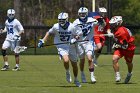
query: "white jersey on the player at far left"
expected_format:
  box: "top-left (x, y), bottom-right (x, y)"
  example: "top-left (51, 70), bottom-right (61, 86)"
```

top-left (4, 19), bottom-right (24, 41)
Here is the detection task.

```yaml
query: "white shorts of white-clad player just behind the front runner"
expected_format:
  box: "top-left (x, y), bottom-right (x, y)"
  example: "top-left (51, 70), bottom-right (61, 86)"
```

top-left (78, 41), bottom-right (94, 59)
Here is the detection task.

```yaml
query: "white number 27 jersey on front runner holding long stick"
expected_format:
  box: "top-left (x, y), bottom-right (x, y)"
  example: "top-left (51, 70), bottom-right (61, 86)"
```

top-left (49, 23), bottom-right (82, 47)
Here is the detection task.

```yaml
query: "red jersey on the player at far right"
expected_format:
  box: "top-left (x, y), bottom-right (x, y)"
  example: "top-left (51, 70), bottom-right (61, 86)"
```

top-left (114, 26), bottom-right (136, 50)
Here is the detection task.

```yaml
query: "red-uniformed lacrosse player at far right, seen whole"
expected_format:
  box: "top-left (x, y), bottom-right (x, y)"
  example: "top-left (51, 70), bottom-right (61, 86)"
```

top-left (109, 16), bottom-right (136, 84)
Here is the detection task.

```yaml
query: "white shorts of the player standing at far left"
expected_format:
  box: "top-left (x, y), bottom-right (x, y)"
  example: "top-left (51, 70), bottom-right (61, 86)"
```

top-left (2, 40), bottom-right (20, 51)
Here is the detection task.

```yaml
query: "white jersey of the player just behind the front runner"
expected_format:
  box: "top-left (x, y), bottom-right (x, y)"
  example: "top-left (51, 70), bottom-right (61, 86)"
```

top-left (73, 17), bottom-right (96, 41)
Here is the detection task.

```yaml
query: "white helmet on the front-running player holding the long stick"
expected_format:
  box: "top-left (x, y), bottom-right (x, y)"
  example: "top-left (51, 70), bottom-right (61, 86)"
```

top-left (58, 12), bottom-right (69, 26)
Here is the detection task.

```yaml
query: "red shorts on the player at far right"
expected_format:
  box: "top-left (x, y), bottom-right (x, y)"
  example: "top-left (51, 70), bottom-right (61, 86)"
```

top-left (113, 49), bottom-right (135, 63)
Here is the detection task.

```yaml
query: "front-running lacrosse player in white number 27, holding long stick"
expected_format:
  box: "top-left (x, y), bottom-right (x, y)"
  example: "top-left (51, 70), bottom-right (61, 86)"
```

top-left (38, 12), bottom-right (82, 87)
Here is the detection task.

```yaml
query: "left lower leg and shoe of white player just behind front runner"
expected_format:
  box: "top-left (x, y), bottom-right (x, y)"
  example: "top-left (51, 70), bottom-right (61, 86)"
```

top-left (80, 58), bottom-right (87, 83)
